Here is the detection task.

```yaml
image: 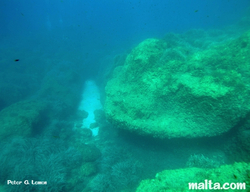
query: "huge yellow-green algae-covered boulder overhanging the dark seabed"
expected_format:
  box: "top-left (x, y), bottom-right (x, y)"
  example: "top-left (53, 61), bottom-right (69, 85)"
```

top-left (105, 32), bottom-right (250, 138)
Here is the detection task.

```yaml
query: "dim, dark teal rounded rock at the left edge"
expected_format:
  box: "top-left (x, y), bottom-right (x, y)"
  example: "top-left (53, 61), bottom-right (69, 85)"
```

top-left (0, 100), bottom-right (46, 139)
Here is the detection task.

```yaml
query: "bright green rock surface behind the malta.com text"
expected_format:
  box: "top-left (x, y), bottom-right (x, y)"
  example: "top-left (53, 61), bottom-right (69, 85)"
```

top-left (136, 163), bottom-right (250, 192)
